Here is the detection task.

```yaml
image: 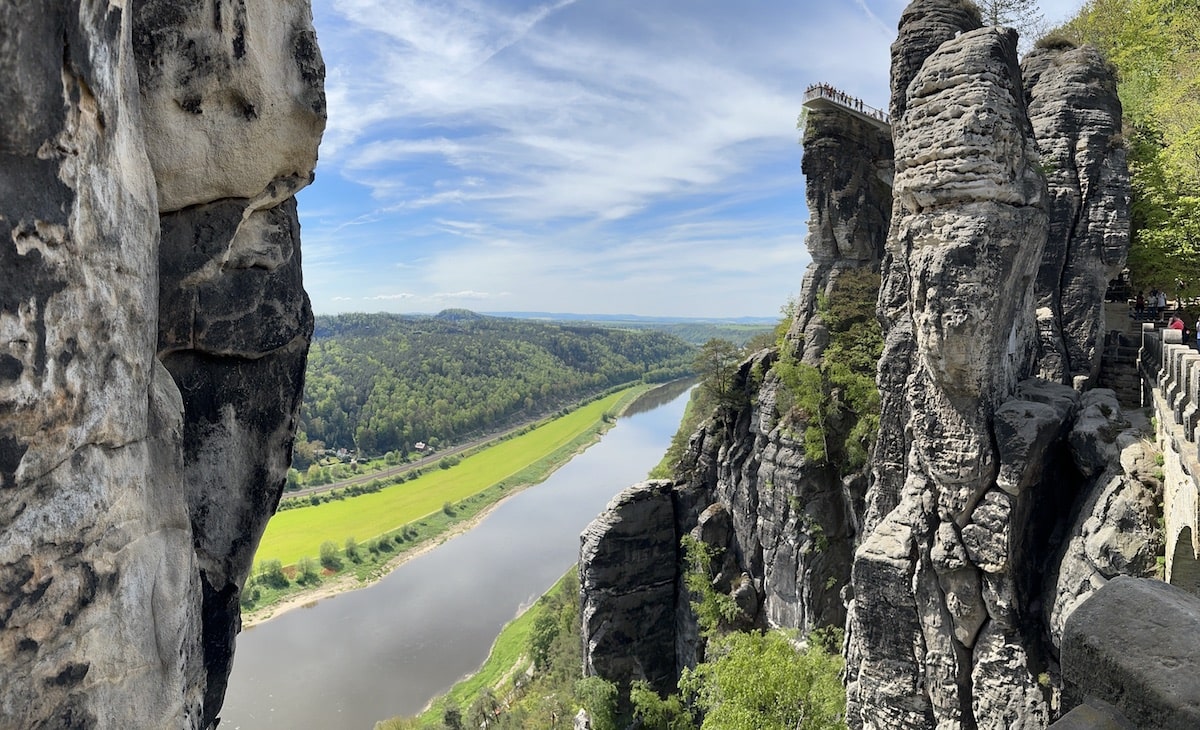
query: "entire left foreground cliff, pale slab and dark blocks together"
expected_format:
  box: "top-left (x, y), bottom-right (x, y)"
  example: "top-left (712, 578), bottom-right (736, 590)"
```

top-left (0, 0), bottom-right (324, 728)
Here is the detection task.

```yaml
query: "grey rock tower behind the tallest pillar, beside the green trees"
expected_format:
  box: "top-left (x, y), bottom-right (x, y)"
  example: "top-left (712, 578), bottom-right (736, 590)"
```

top-left (1021, 46), bottom-right (1129, 389)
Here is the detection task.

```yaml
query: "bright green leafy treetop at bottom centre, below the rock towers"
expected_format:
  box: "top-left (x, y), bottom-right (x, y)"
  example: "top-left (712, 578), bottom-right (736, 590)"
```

top-left (679, 632), bottom-right (846, 730)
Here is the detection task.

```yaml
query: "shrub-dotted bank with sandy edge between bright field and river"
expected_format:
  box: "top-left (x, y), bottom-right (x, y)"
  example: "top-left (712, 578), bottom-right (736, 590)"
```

top-left (242, 384), bottom-right (678, 628)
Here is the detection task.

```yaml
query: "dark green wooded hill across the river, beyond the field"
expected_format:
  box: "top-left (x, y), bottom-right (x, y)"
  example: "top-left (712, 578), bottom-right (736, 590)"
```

top-left (296, 310), bottom-right (694, 468)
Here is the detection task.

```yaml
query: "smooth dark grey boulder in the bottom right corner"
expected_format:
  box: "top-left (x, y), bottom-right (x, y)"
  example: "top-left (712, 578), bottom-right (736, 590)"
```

top-left (1062, 576), bottom-right (1200, 730)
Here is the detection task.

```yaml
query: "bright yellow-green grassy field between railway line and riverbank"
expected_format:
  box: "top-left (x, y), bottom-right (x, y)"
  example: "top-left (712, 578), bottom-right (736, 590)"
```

top-left (254, 387), bottom-right (644, 566)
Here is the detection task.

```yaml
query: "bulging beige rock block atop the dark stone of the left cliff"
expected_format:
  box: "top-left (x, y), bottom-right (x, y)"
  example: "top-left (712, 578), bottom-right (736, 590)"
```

top-left (133, 0), bottom-right (325, 213)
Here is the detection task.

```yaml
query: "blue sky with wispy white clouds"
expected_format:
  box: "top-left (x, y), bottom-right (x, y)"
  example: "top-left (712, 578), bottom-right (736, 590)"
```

top-left (299, 0), bottom-right (1080, 317)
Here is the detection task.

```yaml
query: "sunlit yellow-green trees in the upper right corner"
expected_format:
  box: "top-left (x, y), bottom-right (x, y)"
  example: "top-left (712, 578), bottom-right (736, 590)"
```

top-left (1065, 0), bottom-right (1200, 290)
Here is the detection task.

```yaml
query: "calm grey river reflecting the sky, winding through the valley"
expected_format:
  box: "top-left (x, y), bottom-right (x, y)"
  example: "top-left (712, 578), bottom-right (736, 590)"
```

top-left (221, 384), bottom-right (688, 730)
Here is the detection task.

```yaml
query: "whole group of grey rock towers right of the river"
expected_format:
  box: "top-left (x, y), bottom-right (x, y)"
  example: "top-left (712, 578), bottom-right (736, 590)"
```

top-left (580, 0), bottom-right (1162, 730)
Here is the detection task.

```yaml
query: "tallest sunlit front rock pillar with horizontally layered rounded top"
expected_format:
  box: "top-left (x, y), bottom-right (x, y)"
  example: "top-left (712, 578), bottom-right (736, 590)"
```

top-left (847, 29), bottom-right (1051, 728)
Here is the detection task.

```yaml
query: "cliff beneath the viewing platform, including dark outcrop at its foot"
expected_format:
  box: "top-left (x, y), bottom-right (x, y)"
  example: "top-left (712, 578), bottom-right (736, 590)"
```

top-left (580, 95), bottom-right (892, 692)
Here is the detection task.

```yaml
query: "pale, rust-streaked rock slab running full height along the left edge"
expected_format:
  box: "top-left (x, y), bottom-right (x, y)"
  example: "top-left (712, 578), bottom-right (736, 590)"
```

top-left (0, 0), bottom-right (205, 728)
